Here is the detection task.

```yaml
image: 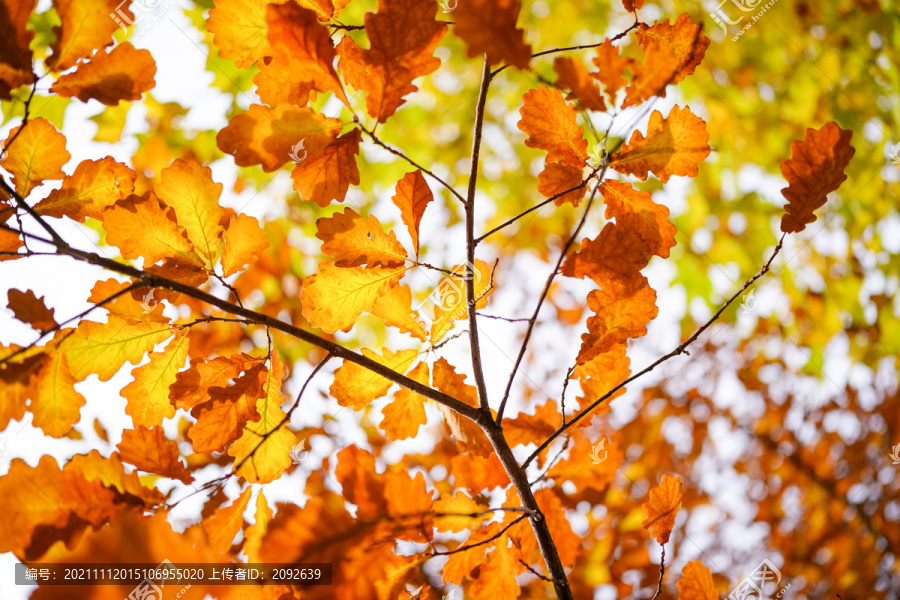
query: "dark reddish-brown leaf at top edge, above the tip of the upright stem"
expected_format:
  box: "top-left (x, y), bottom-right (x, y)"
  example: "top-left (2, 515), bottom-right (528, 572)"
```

top-left (453, 0), bottom-right (531, 70)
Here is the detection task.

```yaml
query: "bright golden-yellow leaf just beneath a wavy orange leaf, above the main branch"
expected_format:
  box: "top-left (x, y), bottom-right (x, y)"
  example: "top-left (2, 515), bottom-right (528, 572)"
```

top-left (300, 263), bottom-right (406, 333)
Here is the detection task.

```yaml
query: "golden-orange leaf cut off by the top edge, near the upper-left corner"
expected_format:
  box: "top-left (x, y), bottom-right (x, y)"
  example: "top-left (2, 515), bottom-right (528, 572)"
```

top-left (47, 0), bottom-right (125, 71)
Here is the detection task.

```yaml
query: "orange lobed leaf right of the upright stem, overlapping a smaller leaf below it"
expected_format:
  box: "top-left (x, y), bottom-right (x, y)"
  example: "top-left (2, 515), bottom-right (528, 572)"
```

top-left (518, 85), bottom-right (587, 167)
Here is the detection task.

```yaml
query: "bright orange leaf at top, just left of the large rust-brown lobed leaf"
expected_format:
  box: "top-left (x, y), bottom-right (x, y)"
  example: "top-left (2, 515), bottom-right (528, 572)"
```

top-left (254, 2), bottom-right (349, 106)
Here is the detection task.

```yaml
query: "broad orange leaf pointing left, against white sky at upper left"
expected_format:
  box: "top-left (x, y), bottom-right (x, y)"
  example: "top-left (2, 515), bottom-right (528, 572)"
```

top-left (50, 42), bottom-right (156, 106)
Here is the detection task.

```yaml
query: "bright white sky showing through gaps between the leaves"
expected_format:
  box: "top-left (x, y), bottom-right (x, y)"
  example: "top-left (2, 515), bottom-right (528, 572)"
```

top-left (0, 0), bottom-right (847, 599)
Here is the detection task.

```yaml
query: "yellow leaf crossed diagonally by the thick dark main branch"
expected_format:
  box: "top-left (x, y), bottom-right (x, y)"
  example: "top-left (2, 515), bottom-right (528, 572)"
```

top-left (328, 348), bottom-right (417, 410)
